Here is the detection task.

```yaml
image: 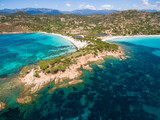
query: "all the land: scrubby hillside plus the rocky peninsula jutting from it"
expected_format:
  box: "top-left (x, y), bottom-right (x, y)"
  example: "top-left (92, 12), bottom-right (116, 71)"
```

top-left (0, 10), bottom-right (160, 104)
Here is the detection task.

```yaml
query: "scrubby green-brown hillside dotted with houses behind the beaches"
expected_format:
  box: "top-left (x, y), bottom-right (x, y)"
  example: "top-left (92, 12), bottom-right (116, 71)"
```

top-left (0, 10), bottom-right (160, 36)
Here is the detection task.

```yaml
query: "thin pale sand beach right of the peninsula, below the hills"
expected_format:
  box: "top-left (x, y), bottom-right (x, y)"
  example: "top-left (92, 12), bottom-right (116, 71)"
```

top-left (98, 35), bottom-right (160, 41)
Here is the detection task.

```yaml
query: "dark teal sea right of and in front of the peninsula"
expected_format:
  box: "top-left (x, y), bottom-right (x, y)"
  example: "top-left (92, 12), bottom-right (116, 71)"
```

top-left (0, 37), bottom-right (160, 120)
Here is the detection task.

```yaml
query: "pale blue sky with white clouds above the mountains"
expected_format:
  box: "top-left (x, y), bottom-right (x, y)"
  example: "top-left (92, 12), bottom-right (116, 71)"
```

top-left (0, 0), bottom-right (160, 11)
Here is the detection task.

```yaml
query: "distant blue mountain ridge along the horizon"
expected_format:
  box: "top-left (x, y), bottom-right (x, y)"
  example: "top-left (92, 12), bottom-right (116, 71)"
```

top-left (0, 8), bottom-right (159, 15)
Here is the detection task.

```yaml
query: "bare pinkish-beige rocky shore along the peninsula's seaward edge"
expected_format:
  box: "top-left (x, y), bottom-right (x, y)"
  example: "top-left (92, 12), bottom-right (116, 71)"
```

top-left (17, 49), bottom-right (126, 104)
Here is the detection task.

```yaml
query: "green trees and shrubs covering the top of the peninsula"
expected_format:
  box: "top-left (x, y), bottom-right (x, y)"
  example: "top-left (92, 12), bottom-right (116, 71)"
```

top-left (23, 36), bottom-right (118, 77)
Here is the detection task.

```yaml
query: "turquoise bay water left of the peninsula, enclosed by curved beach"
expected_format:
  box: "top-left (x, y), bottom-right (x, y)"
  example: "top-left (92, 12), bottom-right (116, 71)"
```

top-left (0, 33), bottom-right (76, 78)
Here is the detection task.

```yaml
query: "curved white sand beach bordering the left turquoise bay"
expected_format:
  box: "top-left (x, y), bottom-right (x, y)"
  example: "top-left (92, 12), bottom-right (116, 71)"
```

top-left (41, 32), bottom-right (88, 49)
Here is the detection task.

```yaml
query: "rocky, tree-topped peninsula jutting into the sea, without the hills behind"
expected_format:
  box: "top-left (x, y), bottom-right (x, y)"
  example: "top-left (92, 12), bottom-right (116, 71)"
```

top-left (17, 35), bottom-right (125, 104)
